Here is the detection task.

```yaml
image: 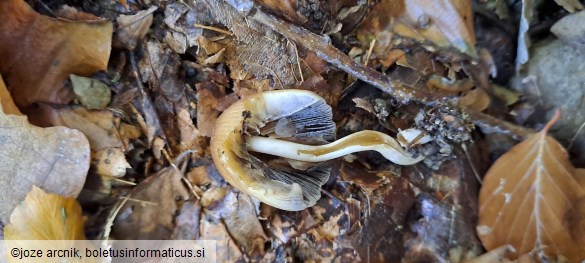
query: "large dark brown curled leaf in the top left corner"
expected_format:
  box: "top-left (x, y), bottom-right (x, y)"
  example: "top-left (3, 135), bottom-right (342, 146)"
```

top-left (0, 0), bottom-right (112, 107)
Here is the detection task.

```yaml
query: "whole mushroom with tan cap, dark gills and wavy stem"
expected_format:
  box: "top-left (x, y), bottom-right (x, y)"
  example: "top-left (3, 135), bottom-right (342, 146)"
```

top-left (211, 89), bottom-right (424, 211)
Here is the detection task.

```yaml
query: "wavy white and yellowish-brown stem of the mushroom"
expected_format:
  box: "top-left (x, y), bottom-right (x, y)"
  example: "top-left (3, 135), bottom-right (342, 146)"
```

top-left (246, 131), bottom-right (424, 165)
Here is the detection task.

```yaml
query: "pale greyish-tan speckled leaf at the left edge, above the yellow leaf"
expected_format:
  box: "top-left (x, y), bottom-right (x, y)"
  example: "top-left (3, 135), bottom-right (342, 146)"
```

top-left (0, 104), bottom-right (89, 224)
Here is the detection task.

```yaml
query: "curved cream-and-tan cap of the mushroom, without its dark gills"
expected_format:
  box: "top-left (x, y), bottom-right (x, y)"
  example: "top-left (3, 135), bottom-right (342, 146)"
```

top-left (211, 90), bottom-right (335, 211)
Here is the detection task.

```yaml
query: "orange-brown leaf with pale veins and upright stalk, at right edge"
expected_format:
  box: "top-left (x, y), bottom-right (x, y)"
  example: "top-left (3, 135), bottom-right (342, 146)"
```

top-left (477, 112), bottom-right (585, 262)
